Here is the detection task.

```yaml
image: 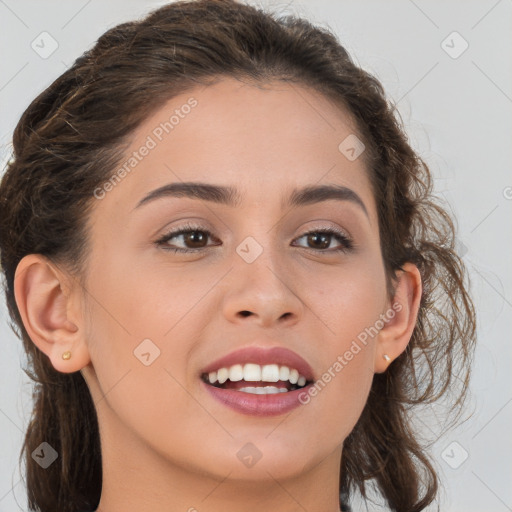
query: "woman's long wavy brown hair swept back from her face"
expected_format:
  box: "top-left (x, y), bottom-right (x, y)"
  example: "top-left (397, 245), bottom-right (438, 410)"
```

top-left (0, 0), bottom-right (475, 512)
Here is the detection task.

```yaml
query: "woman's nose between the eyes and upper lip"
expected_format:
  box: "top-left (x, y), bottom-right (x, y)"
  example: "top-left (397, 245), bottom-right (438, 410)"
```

top-left (223, 240), bottom-right (304, 327)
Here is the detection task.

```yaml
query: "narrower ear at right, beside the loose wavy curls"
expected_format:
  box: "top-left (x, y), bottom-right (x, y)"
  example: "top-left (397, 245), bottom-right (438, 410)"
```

top-left (374, 263), bottom-right (422, 373)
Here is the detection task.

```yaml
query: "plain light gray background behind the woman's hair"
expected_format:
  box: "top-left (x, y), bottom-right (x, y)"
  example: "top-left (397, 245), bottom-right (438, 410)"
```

top-left (0, 0), bottom-right (512, 512)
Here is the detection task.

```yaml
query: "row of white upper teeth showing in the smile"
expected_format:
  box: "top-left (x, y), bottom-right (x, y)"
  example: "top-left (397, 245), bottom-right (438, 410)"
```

top-left (208, 363), bottom-right (306, 386)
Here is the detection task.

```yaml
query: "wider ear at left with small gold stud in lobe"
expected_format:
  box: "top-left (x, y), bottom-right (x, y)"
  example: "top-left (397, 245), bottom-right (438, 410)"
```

top-left (14, 254), bottom-right (90, 373)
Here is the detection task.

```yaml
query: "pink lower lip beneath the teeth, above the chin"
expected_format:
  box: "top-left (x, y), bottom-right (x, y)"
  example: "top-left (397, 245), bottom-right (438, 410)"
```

top-left (201, 381), bottom-right (311, 416)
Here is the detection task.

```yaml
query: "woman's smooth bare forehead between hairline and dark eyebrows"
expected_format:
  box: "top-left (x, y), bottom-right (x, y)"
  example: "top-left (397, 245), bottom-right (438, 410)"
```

top-left (90, 78), bottom-right (373, 221)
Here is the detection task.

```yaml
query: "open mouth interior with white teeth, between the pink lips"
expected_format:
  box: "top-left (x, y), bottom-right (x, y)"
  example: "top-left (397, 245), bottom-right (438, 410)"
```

top-left (201, 363), bottom-right (312, 395)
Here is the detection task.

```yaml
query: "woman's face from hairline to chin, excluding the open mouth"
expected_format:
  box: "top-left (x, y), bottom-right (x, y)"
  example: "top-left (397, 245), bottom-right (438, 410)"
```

top-left (79, 79), bottom-right (389, 479)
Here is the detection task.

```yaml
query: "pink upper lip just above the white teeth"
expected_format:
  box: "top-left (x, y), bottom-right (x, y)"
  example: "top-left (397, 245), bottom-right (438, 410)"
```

top-left (201, 346), bottom-right (314, 381)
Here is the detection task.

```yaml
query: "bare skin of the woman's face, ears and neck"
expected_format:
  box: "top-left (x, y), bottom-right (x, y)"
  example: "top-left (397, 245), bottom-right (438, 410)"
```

top-left (15, 79), bottom-right (421, 512)
